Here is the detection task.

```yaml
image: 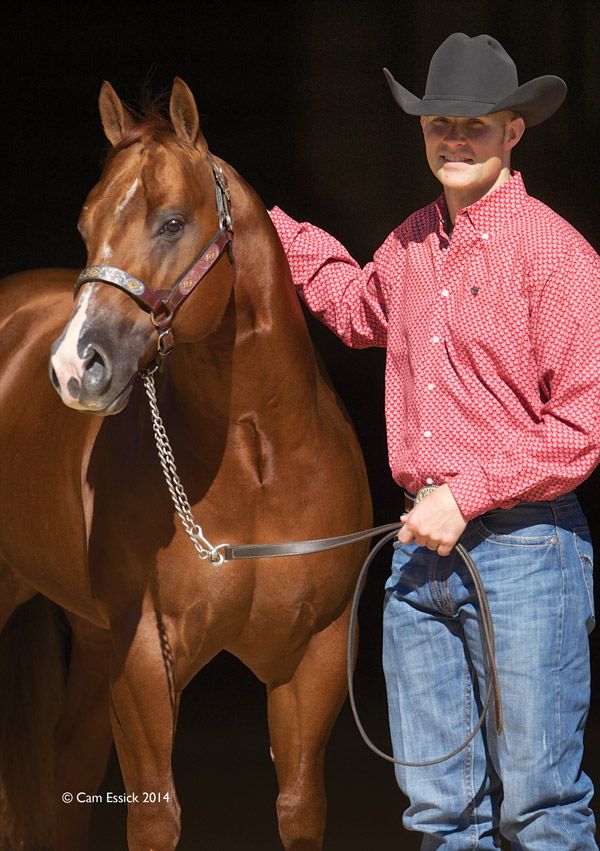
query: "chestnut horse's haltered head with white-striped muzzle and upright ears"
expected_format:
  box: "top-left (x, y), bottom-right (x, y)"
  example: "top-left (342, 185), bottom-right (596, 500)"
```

top-left (50, 79), bottom-right (232, 414)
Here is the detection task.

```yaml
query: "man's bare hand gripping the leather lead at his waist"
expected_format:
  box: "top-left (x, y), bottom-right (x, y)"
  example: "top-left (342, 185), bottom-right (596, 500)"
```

top-left (398, 485), bottom-right (467, 556)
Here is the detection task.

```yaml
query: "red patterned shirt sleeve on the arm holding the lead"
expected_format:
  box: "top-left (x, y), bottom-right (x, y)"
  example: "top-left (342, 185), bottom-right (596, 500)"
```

top-left (448, 246), bottom-right (600, 519)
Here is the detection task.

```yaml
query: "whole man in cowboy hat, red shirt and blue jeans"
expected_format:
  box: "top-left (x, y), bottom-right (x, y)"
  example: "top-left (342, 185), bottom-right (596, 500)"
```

top-left (271, 33), bottom-right (600, 851)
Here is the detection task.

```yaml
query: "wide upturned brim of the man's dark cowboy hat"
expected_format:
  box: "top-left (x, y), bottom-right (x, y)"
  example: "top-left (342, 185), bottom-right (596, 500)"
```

top-left (383, 68), bottom-right (567, 127)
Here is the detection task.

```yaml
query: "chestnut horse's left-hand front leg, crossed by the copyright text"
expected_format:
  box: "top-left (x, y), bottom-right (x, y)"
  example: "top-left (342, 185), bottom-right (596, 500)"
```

top-left (111, 611), bottom-right (181, 851)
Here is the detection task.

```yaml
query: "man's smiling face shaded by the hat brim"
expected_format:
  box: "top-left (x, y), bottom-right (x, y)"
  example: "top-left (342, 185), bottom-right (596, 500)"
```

top-left (421, 112), bottom-right (525, 194)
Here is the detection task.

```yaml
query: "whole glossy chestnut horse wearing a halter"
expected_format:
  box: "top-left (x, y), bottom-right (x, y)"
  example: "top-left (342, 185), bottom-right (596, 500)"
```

top-left (0, 78), bottom-right (371, 851)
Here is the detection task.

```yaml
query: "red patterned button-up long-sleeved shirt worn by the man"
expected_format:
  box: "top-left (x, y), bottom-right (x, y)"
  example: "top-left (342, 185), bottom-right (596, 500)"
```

top-left (271, 172), bottom-right (600, 519)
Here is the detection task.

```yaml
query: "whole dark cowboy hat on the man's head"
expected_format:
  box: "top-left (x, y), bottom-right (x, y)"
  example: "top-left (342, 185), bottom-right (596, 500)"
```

top-left (383, 33), bottom-right (567, 127)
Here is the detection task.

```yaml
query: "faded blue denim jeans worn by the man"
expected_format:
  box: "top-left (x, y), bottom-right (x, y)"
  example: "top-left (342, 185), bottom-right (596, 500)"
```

top-left (383, 494), bottom-right (597, 851)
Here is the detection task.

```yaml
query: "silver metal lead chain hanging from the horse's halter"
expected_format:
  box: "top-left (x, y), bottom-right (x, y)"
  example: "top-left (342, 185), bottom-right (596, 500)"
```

top-left (141, 369), bottom-right (226, 567)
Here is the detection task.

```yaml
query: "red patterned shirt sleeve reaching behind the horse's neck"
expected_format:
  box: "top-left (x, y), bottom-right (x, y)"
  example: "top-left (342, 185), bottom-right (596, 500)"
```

top-left (269, 207), bottom-right (387, 349)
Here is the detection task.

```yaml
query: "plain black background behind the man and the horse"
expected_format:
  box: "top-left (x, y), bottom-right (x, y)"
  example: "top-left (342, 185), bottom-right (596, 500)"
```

top-left (0, 0), bottom-right (600, 851)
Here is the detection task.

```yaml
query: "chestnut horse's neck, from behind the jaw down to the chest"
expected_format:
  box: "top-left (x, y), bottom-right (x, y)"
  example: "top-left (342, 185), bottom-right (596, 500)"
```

top-left (166, 175), bottom-right (318, 427)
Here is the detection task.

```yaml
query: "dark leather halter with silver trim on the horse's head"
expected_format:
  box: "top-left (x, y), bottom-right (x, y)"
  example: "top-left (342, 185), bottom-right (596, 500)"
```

top-left (74, 157), bottom-right (233, 366)
